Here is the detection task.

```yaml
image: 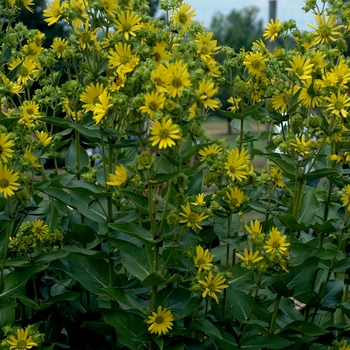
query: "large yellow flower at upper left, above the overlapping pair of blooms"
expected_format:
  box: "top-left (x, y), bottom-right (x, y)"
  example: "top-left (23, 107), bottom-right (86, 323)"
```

top-left (108, 42), bottom-right (138, 73)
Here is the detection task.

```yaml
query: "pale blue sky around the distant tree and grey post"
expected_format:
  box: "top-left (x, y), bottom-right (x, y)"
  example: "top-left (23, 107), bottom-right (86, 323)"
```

top-left (184, 0), bottom-right (315, 30)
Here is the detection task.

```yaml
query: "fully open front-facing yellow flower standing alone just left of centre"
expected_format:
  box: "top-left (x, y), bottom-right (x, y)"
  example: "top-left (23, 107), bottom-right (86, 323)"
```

top-left (150, 118), bottom-right (181, 149)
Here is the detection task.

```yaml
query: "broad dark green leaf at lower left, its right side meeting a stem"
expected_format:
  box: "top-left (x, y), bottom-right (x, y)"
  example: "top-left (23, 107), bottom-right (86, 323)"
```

top-left (66, 254), bottom-right (109, 294)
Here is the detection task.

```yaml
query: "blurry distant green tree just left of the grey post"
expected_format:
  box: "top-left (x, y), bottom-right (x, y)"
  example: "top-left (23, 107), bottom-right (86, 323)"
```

top-left (210, 6), bottom-right (264, 51)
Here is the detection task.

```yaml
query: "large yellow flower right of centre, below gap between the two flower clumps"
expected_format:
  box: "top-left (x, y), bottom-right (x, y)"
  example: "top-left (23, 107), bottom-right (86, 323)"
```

top-left (225, 149), bottom-right (252, 182)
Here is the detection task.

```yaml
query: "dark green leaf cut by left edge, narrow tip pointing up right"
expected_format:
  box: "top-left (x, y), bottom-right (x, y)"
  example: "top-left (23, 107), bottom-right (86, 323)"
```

top-left (0, 264), bottom-right (49, 299)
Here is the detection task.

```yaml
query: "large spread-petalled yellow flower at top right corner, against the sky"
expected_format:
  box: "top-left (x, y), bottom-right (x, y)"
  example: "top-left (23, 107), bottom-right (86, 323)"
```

top-left (307, 13), bottom-right (345, 45)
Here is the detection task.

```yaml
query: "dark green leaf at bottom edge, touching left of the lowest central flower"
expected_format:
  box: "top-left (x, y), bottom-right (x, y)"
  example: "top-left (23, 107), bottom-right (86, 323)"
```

top-left (103, 310), bottom-right (147, 350)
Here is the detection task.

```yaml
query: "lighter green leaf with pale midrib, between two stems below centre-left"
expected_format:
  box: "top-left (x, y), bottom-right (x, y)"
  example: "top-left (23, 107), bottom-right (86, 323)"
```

top-left (114, 240), bottom-right (150, 281)
